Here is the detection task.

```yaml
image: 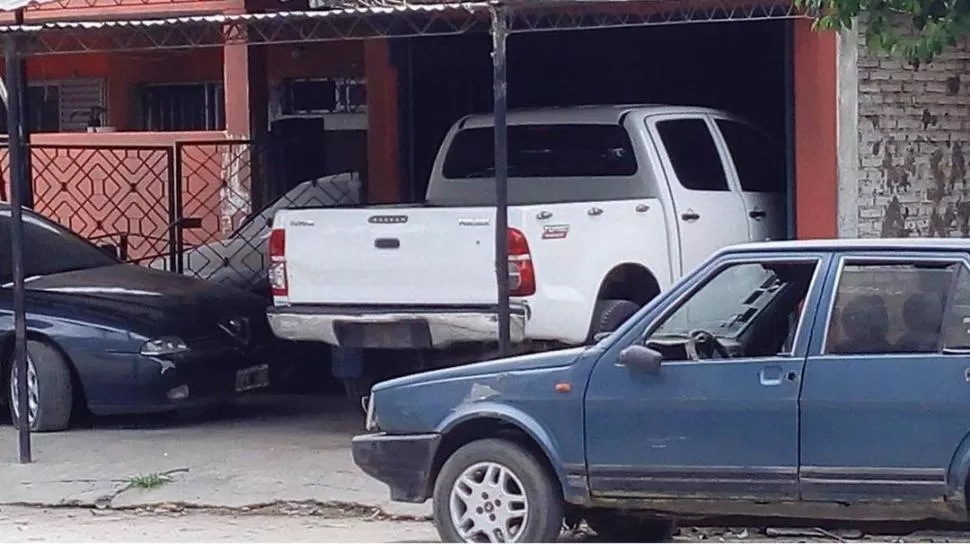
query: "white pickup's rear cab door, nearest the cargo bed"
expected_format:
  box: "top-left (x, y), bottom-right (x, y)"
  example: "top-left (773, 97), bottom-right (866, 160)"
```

top-left (646, 114), bottom-right (749, 271)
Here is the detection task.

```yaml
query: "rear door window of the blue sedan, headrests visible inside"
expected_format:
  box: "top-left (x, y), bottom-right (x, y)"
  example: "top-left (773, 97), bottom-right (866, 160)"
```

top-left (825, 262), bottom-right (962, 355)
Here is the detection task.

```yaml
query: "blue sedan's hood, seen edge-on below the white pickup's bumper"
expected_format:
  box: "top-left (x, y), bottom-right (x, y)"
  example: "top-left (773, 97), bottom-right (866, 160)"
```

top-left (373, 346), bottom-right (587, 393)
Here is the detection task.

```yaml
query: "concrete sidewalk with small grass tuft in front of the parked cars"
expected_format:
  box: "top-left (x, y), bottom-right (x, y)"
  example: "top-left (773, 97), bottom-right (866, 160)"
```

top-left (0, 397), bottom-right (431, 518)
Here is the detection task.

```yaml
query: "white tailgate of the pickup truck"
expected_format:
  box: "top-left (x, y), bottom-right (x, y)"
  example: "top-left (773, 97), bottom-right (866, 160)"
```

top-left (274, 207), bottom-right (497, 305)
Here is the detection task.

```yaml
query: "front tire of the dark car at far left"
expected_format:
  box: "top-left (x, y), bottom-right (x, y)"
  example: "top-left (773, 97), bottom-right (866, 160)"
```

top-left (6, 340), bottom-right (74, 433)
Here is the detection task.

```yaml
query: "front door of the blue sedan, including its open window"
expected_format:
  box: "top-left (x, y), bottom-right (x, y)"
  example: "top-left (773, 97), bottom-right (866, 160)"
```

top-left (586, 253), bottom-right (828, 499)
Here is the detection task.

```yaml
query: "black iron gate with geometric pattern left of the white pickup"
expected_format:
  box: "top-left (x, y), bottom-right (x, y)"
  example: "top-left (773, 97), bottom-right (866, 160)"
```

top-left (0, 140), bottom-right (360, 291)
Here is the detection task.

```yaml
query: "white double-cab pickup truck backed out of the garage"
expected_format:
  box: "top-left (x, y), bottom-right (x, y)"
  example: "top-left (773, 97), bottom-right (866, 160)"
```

top-left (267, 105), bottom-right (785, 360)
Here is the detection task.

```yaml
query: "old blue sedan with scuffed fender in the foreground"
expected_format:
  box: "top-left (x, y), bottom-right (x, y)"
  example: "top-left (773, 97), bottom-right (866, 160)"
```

top-left (353, 239), bottom-right (970, 542)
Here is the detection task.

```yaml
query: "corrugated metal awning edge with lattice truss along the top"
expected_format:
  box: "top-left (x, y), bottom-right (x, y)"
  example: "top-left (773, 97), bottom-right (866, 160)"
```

top-left (0, 0), bottom-right (805, 54)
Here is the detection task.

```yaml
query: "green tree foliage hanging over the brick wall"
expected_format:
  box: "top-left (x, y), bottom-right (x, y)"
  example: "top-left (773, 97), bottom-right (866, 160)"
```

top-left (795, 0), bottom-right (970, 67)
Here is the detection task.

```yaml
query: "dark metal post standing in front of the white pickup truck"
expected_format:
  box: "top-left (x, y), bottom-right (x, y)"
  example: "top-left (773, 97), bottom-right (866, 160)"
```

top-left (491, 6), bottom-right (512, 357)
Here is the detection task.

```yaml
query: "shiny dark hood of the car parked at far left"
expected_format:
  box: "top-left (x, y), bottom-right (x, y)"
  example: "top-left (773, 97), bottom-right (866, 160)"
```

top-left (27, 264), bottom-right (265, 334)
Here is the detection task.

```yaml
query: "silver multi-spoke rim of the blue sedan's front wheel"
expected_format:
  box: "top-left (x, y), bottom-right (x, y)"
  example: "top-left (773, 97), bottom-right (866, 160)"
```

top-left (449, 462), bottom-right (529, 542)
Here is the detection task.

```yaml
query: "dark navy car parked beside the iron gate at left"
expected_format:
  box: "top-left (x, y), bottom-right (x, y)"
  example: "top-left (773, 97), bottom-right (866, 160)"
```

top-left (0, 205), bottom-right (273, 431)
